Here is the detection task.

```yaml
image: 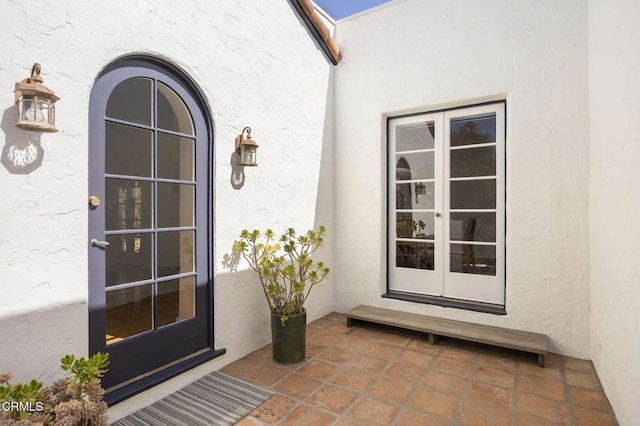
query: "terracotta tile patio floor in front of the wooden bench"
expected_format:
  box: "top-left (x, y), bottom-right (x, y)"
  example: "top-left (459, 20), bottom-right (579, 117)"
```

top-left (223, 314), bottom-right (617, 426)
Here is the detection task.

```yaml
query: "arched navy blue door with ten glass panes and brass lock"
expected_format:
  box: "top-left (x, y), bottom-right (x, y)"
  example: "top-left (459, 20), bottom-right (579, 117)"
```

top-left (87, 58), bottom-right (218, 400)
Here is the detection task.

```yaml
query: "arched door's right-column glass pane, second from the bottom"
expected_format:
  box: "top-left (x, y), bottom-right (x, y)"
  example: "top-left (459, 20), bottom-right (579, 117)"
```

top-left (157, 231), bottom-right (195, 277)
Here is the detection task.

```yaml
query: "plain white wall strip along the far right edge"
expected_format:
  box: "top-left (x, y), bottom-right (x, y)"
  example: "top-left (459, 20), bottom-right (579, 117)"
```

top-left (589, 0), bottom-right (640, 425)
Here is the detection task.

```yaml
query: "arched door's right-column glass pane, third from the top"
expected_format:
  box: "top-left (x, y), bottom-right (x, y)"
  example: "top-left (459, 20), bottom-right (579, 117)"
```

top-left (157, 182), bottom-right (195, 228)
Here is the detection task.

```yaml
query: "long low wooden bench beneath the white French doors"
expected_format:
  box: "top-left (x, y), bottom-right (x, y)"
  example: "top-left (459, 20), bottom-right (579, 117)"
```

top-left (347, 305), bottom-right (549, 367)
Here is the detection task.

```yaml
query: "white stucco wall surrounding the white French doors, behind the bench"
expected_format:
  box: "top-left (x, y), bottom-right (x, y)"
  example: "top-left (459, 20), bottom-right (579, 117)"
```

top-left (334, 0), bottom-right (590, 358)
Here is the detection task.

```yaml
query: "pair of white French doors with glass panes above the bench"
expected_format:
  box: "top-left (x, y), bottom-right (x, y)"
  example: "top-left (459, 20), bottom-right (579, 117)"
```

top-left (388, 103), bottom-right (505, 305)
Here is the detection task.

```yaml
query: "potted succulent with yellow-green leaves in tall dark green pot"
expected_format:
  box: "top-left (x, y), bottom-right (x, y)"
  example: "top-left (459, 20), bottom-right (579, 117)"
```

top-left (233, 225), bottom-right (329, 364)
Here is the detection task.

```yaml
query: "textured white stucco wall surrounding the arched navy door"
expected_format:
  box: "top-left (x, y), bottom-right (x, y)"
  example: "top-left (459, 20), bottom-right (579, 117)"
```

top-left (0, 0), bottom-right (333, 412)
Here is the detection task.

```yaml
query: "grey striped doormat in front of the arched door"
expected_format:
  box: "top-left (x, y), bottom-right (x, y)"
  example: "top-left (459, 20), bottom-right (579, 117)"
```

top-left (112, 371), bottom-right (273, 426)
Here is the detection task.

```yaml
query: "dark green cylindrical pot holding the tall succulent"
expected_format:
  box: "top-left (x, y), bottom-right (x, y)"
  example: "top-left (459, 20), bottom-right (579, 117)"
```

top-left (271, 310), bottom-right (307, 364)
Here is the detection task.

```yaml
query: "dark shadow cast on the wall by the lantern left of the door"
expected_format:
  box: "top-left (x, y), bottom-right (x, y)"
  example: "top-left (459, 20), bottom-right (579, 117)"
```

top-left (0, 105), bottom-right (44, 175)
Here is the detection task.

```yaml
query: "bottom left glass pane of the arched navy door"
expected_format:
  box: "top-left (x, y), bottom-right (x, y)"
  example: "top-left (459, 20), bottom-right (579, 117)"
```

top-left (105, 284), bottom-right (153, 345)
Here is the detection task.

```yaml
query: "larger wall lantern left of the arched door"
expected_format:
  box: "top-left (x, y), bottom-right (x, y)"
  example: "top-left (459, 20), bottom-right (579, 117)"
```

top-left (14, 63), bottom-right (60, 133)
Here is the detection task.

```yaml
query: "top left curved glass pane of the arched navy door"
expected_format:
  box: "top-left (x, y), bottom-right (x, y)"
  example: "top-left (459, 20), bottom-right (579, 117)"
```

top-left (106, 77), bottom-right (153, 126)
